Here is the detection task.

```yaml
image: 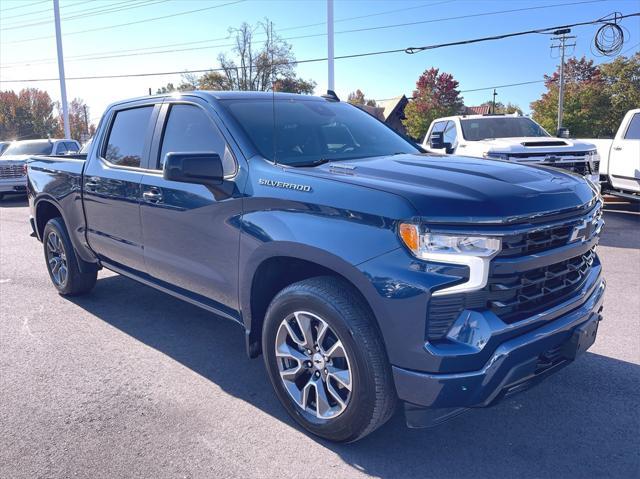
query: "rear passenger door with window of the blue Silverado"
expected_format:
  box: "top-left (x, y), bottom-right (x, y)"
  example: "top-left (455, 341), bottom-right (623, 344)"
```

top-left (83, 102), bottom-right (160, 274)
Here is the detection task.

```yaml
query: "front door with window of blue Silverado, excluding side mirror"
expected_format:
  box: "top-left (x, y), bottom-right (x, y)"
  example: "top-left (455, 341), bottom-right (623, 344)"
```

top-left (141, 98), bottom-right (242, 316)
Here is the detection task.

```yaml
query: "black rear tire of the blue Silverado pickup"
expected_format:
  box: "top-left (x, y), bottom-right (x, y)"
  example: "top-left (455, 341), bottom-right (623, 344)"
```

top-left (42, 218), bottom-right (98, 296)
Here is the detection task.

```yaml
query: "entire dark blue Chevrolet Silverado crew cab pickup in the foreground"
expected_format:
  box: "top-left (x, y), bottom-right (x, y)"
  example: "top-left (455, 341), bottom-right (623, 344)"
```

top-left (28, 92), bottom-right (605, 442)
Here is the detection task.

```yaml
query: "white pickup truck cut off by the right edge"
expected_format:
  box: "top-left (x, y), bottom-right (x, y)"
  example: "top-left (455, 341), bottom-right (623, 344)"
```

top-left (585, 108), bottom-right (640, 200)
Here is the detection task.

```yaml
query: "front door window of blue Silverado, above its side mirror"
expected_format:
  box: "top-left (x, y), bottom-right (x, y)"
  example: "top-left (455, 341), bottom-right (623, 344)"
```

top-left (159, 104), bottom-right (236, 175)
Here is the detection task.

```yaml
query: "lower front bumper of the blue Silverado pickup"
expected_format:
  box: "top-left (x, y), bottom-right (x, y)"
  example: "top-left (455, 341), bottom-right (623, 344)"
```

top-left (392, 278), bottom-right (605, 416)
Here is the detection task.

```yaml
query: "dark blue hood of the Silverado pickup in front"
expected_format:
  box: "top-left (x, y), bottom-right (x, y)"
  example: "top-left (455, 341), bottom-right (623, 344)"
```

top-left (296, 155), bottom-right (595, 223)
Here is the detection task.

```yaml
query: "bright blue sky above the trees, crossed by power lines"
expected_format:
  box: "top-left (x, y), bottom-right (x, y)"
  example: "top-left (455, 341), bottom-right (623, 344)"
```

top-left (0, 0), bottom-right (640, 121)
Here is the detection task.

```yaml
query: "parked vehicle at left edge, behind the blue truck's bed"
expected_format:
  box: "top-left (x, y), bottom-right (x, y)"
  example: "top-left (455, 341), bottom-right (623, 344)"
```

top-left (0, 139), bottom-right (80, 200)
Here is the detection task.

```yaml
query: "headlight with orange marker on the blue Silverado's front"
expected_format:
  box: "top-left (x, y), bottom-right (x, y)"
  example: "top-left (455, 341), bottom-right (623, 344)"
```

top-left (399, 223), bottom-right (502, 296)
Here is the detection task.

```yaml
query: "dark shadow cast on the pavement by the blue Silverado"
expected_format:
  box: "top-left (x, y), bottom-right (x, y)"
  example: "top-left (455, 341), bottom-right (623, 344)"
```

top-left (73, 276), bottom-right (640, 478)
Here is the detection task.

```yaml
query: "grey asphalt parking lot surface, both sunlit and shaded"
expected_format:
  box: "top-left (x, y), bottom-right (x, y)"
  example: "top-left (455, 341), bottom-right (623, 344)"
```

top-left (0, 199), bottom-right (640, 479)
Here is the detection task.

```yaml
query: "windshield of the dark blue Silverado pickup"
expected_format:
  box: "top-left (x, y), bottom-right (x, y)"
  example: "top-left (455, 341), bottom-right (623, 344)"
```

top-left (222, 99), bottom-right (420, 166)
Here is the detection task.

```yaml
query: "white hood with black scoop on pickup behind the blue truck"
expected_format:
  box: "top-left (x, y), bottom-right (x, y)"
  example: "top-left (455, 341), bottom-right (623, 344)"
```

top-left (471, 136), bottom-right (596, 153)
